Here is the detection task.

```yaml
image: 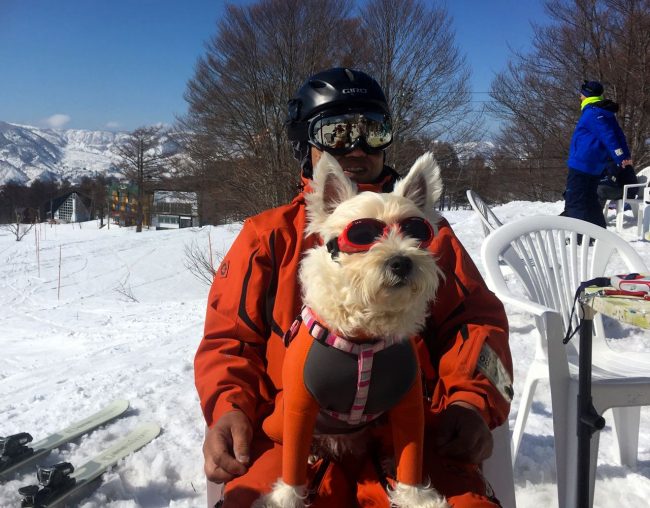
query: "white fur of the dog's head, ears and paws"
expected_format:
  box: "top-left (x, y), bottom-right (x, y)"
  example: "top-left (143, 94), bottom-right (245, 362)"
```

top-left (253, 153), bottom-right (449, 508)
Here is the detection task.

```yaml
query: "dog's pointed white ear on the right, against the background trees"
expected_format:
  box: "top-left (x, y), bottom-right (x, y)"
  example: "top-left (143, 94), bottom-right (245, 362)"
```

top-left (393, 152), bottom-right (442, 213)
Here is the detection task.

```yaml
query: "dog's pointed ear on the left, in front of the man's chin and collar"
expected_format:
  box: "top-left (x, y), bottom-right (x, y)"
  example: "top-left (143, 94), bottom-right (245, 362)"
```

top-left (307, 152), bottom-right (357, 217)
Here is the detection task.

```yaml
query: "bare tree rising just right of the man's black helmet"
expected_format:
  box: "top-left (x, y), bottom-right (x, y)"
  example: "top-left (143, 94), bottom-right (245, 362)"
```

top-left (360, 0), bottom-right (482, 173)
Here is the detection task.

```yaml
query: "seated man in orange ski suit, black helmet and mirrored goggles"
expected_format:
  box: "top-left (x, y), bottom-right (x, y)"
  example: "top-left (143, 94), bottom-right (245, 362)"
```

top-left (194, 68), bottom-right (513, 508)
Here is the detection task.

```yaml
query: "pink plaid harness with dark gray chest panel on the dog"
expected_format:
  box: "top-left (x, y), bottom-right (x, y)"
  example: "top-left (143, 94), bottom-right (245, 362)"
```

top-left (284, 306), bottom-right (419, 433)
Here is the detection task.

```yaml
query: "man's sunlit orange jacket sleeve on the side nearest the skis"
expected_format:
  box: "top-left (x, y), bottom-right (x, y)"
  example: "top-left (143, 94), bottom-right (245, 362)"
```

top-left (194, 221), bottom-right (270, 426)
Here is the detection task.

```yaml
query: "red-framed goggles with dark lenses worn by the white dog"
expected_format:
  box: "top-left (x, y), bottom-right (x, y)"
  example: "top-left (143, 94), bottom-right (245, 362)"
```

top-left (327, 217), bottom-right (434, 256)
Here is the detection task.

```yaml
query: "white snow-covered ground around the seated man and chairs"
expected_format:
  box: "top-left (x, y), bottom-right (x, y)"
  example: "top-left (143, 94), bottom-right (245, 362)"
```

top-left (0, 202), bottom-right (650, 508)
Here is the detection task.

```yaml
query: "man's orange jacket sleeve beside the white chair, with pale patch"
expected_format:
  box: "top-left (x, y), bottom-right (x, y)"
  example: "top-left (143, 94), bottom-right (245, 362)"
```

top-left (422, 220), bottom-right (512, 428)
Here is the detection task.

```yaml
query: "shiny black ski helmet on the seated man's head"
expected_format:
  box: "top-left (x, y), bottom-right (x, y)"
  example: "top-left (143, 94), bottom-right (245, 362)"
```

top-left (287, 67), bottom-right (390, 141)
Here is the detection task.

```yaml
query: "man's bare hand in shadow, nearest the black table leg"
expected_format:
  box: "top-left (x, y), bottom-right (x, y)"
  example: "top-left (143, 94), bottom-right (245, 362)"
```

top-left (434, 402), bottom-right (493, 464)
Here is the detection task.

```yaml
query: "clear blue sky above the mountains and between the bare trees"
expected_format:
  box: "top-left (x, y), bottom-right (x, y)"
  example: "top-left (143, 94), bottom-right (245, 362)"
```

top-left (0, 0), bottom-right (544, 130)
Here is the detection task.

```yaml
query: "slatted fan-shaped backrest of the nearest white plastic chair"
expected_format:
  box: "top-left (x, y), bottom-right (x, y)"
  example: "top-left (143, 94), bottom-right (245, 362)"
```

top-left (481, 215), bottom-right (648, 358)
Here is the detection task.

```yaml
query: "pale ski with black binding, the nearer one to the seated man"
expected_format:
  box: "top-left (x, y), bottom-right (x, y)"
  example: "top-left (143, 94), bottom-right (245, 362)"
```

top-left (18, 423), bottom-right (160, 508)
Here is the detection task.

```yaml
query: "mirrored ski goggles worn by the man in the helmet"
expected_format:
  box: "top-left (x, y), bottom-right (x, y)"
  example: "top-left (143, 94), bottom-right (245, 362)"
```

top-left (308, 112), bottom-right (393, 155)
